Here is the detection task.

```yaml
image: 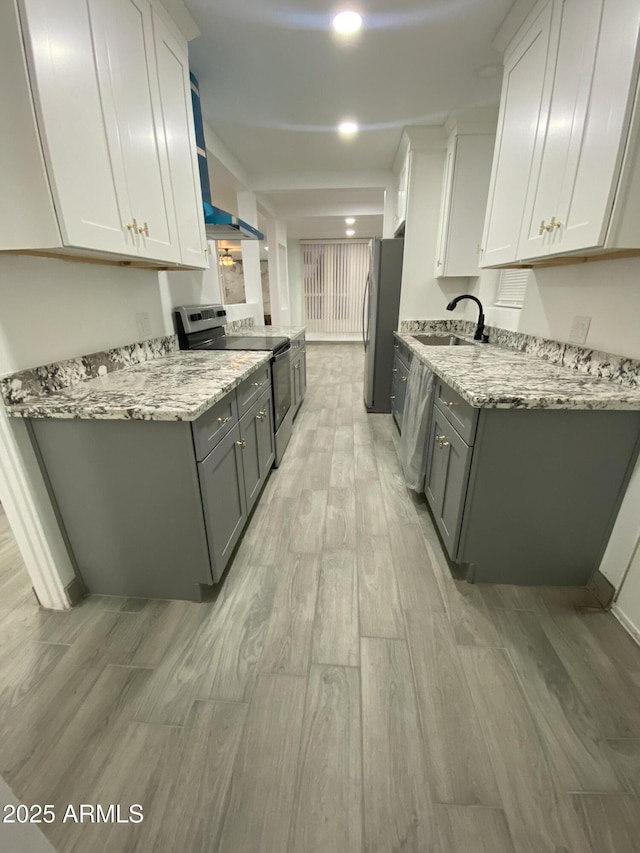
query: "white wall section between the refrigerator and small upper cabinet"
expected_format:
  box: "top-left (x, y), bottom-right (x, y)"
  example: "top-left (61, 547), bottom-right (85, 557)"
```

top-left (400, 144), bottom-right (469, 320)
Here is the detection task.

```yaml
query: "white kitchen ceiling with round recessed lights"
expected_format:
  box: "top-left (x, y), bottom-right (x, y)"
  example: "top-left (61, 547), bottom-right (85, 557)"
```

top-left (186, 0), bottom-right (512, 236)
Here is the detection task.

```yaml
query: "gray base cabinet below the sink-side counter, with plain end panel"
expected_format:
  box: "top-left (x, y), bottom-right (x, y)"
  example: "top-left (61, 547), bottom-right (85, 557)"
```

top-left (425, 383), bottom-right (640, 586)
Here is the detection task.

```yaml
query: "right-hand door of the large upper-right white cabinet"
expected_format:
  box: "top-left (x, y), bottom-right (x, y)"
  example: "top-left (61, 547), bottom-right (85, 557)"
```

top-left (552, 0), bottom-right (640, 253)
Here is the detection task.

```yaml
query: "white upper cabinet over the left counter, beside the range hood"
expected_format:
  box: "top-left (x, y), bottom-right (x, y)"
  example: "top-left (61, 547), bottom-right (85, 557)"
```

top-left (0, 0), bottom-right (208, 267)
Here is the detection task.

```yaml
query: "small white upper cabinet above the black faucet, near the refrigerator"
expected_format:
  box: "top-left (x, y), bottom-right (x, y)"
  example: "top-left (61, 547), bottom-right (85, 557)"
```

top-left (435, 133), bottom-right (495, 278)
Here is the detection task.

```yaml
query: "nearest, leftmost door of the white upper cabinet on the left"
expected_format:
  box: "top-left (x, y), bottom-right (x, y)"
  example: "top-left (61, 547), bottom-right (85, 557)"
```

top-left (21, 0), bottom-right (137, 255)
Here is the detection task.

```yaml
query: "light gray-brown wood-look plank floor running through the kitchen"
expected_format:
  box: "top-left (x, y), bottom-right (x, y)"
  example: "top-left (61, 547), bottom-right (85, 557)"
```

top-left (0, 344), bottom-right (640, 853)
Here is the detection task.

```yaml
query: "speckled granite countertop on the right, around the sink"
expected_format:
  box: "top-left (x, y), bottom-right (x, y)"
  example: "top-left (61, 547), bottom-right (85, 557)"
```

top-left (394, 332), bottom-right (640, 410)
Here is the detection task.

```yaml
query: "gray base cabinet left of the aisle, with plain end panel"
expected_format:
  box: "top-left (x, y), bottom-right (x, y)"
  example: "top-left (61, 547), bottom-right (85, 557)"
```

top-left (29, 366), bottom-right (274, 601)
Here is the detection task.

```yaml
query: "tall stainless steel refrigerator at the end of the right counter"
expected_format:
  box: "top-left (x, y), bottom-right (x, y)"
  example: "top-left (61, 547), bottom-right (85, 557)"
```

top-left (362, 237), bottom-right (404, 412)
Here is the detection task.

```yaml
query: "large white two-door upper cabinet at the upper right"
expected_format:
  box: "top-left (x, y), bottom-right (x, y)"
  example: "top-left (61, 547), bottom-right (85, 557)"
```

top-left (482, 0), bottom-right (640, 266)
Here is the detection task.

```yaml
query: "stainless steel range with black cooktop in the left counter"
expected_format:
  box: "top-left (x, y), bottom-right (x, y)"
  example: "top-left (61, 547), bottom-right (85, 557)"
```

top-left (174, 305), bottom-right (292, 467)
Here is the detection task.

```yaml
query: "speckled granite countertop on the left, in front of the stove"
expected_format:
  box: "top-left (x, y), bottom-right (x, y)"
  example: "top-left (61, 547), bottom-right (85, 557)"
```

top-left (7, 351), bottom-right (271, 421)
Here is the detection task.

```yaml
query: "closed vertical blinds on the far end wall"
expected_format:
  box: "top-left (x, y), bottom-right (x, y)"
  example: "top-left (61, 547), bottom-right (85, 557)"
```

top-left (301, 241), bottom-right (370, 332)
